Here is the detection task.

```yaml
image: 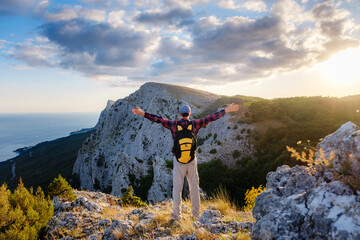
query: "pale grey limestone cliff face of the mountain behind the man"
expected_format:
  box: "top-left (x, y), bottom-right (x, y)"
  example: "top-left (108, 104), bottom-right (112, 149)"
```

top-left (73, 83), bottom-right (254, 201)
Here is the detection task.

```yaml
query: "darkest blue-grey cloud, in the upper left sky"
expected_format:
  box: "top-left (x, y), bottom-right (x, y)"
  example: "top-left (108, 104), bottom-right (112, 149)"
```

top-left (42, 19), bottom-right (153, 67)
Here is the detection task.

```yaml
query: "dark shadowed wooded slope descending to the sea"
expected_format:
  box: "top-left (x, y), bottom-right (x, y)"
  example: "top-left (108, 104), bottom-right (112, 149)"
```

top-left (0, 132), bottom-right (92, 189)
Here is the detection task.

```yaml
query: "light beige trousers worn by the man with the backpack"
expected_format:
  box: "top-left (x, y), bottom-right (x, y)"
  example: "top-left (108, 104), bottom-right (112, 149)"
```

top-left (173, 157), bottom-right (200, 220)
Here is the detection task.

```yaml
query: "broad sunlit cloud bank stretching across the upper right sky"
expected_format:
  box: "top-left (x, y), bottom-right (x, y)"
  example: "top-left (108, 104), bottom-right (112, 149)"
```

top-left (150, 0), bottom-right (359, 82)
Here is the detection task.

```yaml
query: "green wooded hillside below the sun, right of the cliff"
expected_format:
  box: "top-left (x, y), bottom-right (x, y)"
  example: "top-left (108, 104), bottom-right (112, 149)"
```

top-left (199, 95), bottom-right (360, 206)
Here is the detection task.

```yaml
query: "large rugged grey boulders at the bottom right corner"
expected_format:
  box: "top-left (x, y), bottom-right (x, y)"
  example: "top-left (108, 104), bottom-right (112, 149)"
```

top-left (252, 122), bottom-right (360, 239)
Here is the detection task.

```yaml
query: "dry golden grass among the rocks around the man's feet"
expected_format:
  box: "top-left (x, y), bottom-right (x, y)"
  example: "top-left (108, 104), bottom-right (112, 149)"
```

top-left (96, 189), bottom-right (254, 240)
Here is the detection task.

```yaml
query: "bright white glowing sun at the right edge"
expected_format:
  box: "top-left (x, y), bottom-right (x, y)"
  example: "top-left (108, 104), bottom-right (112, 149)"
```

top-left (323, 48), bottom-right (360, 84)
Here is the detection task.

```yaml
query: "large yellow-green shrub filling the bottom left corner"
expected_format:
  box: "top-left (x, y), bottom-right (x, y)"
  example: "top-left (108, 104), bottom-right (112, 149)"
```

top-left (0, 178), bottom-right (54, 240)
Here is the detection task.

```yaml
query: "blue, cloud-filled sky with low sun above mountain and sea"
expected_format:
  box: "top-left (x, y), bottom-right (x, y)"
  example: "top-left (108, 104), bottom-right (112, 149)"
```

top-left (0, 0), bottom-right (360, 113)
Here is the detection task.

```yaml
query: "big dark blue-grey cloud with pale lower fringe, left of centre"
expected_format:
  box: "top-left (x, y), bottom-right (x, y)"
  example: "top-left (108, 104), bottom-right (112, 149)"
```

top-left (42, 19), bottom-right (155, 78)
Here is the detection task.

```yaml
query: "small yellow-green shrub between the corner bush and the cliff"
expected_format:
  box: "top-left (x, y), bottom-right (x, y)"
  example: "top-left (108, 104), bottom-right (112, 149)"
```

top-left (47, 174), bottom-right (76, 201)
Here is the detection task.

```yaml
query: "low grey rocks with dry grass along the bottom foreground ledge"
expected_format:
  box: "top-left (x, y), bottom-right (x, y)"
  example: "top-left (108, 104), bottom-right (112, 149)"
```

top-left (45, 190), bottom-right (253, 240)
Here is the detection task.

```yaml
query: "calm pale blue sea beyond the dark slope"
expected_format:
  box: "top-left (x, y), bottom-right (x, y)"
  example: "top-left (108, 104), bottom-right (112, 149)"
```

top-left (0, 112), bottom-right (100, 162)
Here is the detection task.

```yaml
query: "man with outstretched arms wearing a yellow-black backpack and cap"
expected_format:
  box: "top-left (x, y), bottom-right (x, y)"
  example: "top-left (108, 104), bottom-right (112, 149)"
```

top-left (131, 104), bottom-right (239, 221)
